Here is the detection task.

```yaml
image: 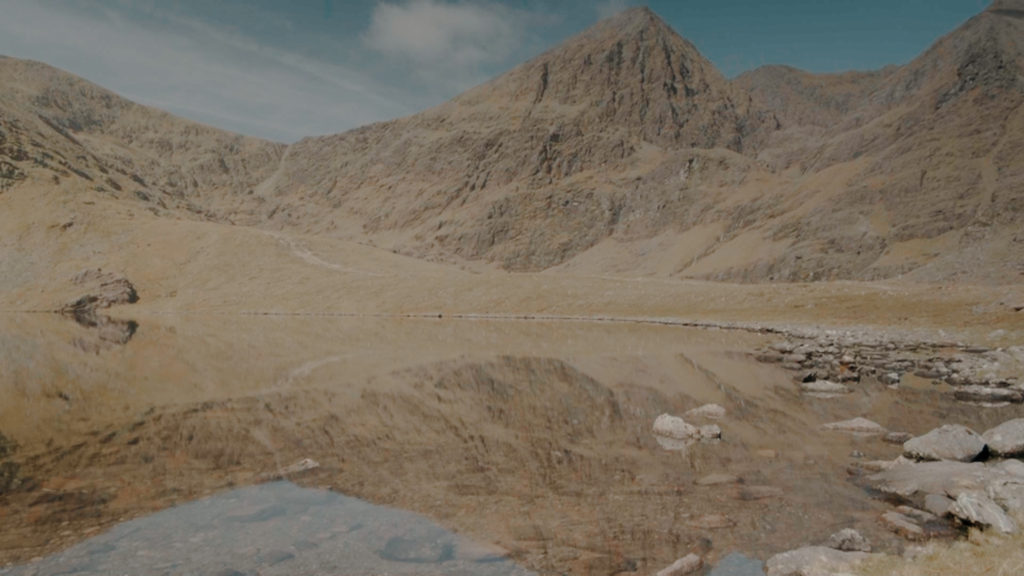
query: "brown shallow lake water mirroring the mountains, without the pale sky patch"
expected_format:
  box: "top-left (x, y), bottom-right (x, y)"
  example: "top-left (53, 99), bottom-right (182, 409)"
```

top-left (0, 315), bottom-right (1021, 574)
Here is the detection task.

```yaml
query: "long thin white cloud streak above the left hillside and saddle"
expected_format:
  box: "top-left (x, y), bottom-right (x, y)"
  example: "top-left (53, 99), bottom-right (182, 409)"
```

top-left (0, 0), bottom-right (414, 140)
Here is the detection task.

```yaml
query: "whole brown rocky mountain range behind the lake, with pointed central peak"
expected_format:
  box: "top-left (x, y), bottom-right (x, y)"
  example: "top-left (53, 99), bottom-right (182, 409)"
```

top-left (0, 0), bottom-right (1024, 283)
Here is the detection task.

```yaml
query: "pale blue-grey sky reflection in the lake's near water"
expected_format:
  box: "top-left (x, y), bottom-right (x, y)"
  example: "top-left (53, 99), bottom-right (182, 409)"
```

top-left (6, 482), bottom-right (529, 576)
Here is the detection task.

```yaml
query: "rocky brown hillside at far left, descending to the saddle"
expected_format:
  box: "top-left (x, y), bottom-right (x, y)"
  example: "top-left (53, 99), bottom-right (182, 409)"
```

top-left (0, 57), bottom-right (285, 219)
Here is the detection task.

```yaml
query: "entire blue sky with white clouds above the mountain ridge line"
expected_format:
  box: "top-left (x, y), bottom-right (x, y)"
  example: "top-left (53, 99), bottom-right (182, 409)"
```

top-left (0, 0), bottom-right (988, 141)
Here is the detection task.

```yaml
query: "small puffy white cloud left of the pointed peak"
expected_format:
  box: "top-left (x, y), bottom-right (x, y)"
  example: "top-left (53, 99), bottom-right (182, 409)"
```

top-left (364, 0), bottom-right (530, 88)
